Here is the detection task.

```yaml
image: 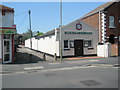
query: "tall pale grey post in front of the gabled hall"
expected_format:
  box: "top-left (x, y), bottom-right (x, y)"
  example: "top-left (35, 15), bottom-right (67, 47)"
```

top-left (60, 0), bottom-right (62, 61)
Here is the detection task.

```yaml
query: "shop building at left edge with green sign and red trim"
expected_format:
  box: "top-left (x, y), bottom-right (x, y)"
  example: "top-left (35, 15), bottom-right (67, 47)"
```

top-left (0, 5), bottom-right (16, 63)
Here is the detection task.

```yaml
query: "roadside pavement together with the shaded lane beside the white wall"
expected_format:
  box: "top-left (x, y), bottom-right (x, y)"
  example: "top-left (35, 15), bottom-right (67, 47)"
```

top-left (0, 46), bottom-right (120, 74)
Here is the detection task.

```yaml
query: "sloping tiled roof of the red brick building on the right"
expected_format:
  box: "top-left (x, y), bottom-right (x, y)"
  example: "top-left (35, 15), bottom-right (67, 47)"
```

top-left (81, 2), bottom-right (114, 19)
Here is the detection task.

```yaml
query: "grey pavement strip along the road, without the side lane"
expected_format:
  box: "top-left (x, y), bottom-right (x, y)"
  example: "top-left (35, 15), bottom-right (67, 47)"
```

top-left (0, 57), bottom-right (119, 74)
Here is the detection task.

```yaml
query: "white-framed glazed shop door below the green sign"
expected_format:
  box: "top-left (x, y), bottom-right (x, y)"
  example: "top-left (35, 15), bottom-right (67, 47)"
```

top-left (3, 34), bottom-right (12, 63)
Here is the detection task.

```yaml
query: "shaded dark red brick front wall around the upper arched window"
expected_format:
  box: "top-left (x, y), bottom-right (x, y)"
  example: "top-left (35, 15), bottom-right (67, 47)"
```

top-left (106, 2), bottom-right (120, 43)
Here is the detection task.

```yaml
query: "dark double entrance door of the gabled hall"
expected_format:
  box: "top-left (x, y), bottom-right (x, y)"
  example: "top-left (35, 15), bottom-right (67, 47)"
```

top-left (74, 40), bottom-right (83, 56)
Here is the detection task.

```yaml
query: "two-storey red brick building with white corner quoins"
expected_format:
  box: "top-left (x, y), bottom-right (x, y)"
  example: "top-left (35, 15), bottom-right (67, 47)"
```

top-left (81, 1), bottom-right (120, 55)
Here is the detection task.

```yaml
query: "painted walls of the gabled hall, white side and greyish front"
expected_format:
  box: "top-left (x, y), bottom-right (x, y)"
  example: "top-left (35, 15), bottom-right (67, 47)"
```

top-left (25, 21), bottom-right (98, 56)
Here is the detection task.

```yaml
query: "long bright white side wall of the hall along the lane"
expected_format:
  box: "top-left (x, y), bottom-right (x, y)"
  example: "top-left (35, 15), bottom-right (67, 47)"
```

top-left (25, 35), bottom-right (59, 56)
